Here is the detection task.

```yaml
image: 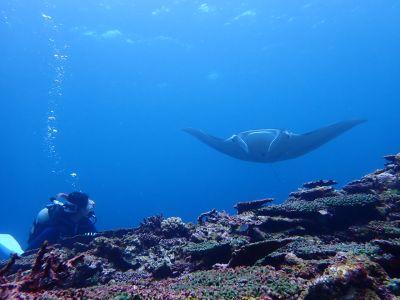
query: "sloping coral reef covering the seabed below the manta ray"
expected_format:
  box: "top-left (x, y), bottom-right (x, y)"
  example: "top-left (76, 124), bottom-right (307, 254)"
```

top-left (0, 154), bottom-right (400, 299)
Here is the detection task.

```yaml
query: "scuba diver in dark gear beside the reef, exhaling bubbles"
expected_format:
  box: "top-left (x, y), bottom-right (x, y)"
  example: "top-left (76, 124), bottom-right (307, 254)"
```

top-left (27, 192), bottom-right (97, 250)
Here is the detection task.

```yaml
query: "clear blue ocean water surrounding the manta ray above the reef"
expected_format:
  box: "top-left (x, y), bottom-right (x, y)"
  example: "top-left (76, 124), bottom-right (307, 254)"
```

top-left (0, 0), bottom-right (400, 244)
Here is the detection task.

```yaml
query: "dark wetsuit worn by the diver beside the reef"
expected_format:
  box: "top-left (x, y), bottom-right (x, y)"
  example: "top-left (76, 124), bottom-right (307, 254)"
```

top-left (27, 204), bottom-right (97, 250)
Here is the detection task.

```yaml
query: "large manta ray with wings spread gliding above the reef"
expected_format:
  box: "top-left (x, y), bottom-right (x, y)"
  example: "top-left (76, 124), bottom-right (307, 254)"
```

top-left (183, 120), bottom-right (365, 163)
